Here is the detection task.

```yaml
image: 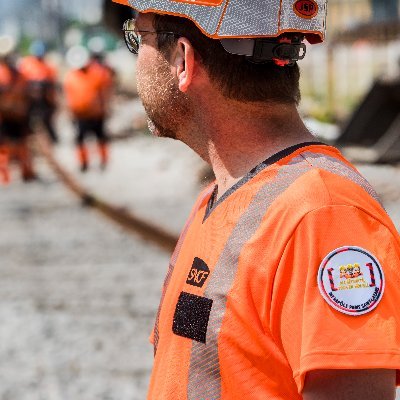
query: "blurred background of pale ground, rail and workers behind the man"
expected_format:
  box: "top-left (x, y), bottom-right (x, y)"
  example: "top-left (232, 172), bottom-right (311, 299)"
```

top-left (0, 0), bottom-right (400, 400)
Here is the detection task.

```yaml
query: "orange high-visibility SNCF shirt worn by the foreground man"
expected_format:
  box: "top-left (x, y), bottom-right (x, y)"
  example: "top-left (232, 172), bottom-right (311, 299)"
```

top-left (148, 144), bottom-right (400, 400)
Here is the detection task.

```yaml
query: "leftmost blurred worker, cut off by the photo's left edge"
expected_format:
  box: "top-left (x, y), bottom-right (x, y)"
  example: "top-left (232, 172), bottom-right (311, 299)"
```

top-left (0, 37), bottom-right (36, 183)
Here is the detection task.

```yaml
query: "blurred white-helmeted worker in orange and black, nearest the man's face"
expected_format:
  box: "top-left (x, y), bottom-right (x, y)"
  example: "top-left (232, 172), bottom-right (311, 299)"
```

top-left (64, 46), bottom-right (112, 172)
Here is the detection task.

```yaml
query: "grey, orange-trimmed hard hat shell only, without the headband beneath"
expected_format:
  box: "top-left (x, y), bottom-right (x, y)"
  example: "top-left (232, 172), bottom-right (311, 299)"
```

top-left (113, 0), bottom-right (328, 44)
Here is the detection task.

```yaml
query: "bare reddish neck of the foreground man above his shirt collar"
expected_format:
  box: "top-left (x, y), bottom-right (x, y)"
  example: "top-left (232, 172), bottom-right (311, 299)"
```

top-left (189, 98), bottom-right (315, 198)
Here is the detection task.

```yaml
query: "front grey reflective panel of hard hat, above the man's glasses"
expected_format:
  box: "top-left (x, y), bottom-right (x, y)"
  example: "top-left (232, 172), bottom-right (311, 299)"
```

top-left (129, 0), bottom-right (227, 36)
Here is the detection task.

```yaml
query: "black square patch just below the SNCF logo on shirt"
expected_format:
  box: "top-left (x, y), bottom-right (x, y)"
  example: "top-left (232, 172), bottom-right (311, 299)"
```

top-left (172, 292), bottom-right (213, 343)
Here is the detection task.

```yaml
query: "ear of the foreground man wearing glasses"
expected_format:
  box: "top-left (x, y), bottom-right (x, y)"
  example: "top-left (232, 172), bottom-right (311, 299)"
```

top-left (172, 37), bottom-right (196, 93)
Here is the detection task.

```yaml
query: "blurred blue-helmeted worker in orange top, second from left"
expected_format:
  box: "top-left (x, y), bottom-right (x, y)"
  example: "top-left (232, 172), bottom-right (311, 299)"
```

top-left (19, 40), bottom-right (58, 143)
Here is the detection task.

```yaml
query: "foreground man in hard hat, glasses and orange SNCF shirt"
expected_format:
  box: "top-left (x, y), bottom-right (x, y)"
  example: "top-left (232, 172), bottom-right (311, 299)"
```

top-left (111, 0), bottom-right (400, 400)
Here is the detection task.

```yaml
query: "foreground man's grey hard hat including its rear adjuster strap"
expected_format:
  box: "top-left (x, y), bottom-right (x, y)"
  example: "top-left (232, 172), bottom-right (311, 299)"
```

top-left (113, 0), bottom-right (328, 65)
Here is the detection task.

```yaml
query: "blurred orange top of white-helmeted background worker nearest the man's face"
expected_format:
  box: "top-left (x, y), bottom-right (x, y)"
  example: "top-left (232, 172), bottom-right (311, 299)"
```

top-left (64, 68), bottom-right (106, 118)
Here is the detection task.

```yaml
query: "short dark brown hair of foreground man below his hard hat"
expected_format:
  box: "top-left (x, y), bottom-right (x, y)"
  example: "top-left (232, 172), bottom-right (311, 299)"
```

top-left (153, 14), bottom-right (300, 104)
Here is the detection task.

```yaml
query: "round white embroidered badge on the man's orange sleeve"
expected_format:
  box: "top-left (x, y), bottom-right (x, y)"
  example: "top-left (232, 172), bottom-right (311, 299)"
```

top-left (318, 246), bottom-right (385, 315)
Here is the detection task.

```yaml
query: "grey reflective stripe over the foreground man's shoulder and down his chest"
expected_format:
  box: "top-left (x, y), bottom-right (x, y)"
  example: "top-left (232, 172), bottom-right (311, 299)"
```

top-left (187, 152), bottom-right (379, 400)
